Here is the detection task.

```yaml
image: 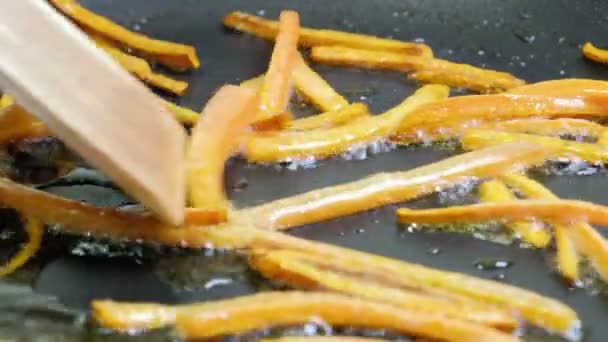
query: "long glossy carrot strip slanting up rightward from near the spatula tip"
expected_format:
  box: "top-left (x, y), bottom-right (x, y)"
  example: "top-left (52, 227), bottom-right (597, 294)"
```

top-left (235, 144), bottom-right (545, 229)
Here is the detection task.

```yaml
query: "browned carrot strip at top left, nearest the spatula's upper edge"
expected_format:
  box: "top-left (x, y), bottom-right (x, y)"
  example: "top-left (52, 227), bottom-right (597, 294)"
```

top-left (50, 0), bottom-right (200, 70)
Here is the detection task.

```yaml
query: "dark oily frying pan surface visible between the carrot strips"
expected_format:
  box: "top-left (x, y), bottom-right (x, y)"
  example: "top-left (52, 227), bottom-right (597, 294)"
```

top-left (0, 0), bottom-right (608, 342)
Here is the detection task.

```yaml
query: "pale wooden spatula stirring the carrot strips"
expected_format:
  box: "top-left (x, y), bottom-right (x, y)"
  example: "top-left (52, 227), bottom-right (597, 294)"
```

top-left (0, 0), bottom-right (185, 224)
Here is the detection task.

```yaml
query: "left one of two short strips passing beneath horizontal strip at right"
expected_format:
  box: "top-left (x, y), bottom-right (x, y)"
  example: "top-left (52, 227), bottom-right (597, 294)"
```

top-left (479, 180), bottom-right (551, 248)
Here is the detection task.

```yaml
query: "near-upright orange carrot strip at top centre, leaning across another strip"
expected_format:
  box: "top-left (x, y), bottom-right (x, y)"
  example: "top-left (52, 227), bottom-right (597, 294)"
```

top-left (256, 11), bottom-right (300, 127)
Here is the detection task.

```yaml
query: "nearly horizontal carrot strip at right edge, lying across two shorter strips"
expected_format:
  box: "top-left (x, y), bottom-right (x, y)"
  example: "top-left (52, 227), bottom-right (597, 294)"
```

top-left (397, 200), bottom-right (608, 225)
